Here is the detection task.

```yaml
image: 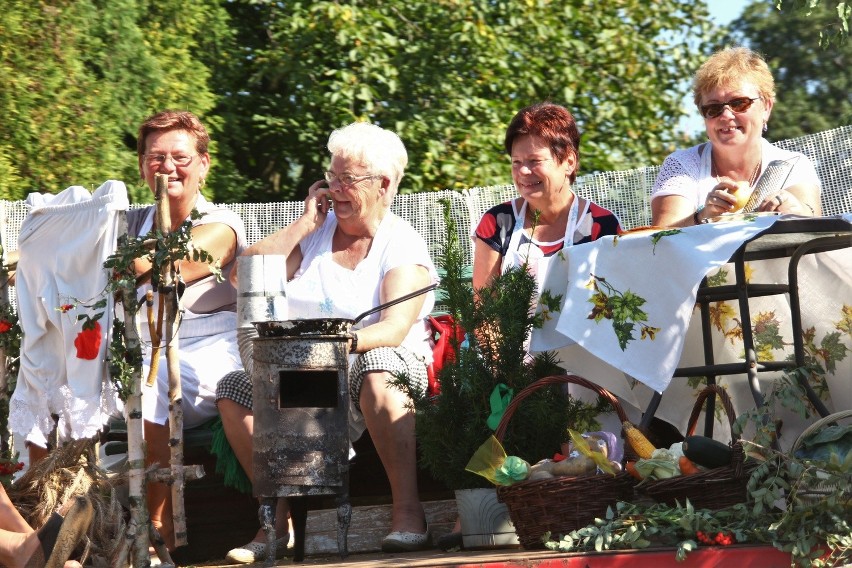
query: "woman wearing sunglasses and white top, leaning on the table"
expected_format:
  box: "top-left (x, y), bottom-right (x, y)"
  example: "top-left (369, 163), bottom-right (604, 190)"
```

top-left (651, 47), bottom-right (820, 227)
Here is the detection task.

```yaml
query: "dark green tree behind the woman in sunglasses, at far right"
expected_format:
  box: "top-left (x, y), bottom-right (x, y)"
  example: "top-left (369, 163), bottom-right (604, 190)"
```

top-left (732, 1), bottom-right (852, 141)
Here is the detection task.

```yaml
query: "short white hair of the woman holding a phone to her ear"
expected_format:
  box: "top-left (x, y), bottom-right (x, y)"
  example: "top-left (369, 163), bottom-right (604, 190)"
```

top-left (328, 122), bottom-right (408, 206)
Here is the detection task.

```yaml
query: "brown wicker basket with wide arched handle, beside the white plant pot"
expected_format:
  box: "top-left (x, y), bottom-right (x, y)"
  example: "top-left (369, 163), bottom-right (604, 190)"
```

top-left (494, 375), bottom-right (634, 549)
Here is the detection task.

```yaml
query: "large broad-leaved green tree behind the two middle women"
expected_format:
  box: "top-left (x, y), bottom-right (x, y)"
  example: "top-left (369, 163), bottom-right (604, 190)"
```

top-left (216, 0), bottom-right (710, 201)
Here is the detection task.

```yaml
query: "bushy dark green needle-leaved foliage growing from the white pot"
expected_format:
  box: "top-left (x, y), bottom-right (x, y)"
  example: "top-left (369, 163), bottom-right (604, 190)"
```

top-left (410, 204), bottom-right (609, 489)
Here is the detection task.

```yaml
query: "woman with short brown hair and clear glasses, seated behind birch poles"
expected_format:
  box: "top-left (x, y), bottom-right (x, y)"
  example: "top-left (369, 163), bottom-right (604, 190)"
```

top-left (127, 110), bottom-right (247, 550)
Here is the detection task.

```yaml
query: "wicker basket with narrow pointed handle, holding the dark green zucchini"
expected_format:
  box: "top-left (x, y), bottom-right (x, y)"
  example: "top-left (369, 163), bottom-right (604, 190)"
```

top-left (637, 385), bottom-right (757, 509)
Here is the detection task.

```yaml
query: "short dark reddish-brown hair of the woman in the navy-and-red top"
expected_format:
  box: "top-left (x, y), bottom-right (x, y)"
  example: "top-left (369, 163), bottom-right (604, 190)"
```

top-left (504, 102), bottom-right (580, 183)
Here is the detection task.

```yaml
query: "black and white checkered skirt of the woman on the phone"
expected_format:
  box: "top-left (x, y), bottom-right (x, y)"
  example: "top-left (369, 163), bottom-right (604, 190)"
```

top-left (216, 347), bottom-right (429, 411)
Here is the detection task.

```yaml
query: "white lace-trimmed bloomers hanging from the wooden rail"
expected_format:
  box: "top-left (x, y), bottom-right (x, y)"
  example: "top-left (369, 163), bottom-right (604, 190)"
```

top-left (9, 181), bottom-right (129, 447)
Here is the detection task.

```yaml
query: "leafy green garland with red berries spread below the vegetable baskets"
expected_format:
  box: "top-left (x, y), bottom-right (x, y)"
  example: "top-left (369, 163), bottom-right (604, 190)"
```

top-left (543, 368), bottom-right (852, 568)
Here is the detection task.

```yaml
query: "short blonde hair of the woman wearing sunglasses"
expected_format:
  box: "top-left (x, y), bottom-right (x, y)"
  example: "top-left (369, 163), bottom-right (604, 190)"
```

top-left (692, 47), bottom-right (775, 109)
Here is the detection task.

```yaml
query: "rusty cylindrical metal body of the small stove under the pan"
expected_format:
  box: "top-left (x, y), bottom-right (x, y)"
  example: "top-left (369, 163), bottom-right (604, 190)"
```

top-left (252, 337), bottom-right (349, 497)
